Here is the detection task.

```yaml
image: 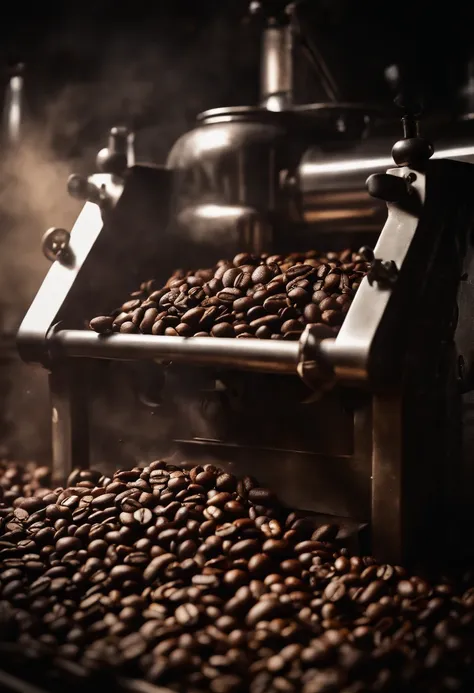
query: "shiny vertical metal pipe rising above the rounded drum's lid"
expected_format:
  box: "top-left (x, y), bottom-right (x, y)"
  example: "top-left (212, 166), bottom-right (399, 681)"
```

top-left (261, 23), bottom-right (293, 111)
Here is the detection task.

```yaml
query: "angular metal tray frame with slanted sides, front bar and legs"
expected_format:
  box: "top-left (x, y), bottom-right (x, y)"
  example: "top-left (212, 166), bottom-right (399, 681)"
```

top-left (18, 155), bottom-right (474, 561)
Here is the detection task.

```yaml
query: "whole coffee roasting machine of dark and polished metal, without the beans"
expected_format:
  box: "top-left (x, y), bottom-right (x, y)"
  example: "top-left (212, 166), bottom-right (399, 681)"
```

top-left (14, 4), bottom-right (474, 562)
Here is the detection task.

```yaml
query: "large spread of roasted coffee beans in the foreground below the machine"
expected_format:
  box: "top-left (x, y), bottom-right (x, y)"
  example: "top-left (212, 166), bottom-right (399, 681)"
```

top-left (0, 461), bottom-right (474, 693)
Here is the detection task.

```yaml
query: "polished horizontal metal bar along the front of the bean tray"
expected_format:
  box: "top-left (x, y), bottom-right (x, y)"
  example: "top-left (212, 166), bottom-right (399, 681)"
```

top-left (50, 330), bottom-right (300, 374)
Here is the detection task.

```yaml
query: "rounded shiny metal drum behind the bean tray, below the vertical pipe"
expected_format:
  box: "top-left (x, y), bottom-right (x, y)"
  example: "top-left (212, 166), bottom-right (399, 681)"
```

top-left (167, 105), bottom-right (372, 254)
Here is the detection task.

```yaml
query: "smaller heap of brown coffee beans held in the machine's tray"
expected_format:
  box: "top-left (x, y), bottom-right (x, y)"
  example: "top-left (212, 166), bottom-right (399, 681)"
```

top-left (90, 250), bottom-right (369, 340)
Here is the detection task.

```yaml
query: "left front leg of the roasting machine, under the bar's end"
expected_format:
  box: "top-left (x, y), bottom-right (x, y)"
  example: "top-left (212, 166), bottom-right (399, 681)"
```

top-left (49, 359), bottom-right (89, 484)
